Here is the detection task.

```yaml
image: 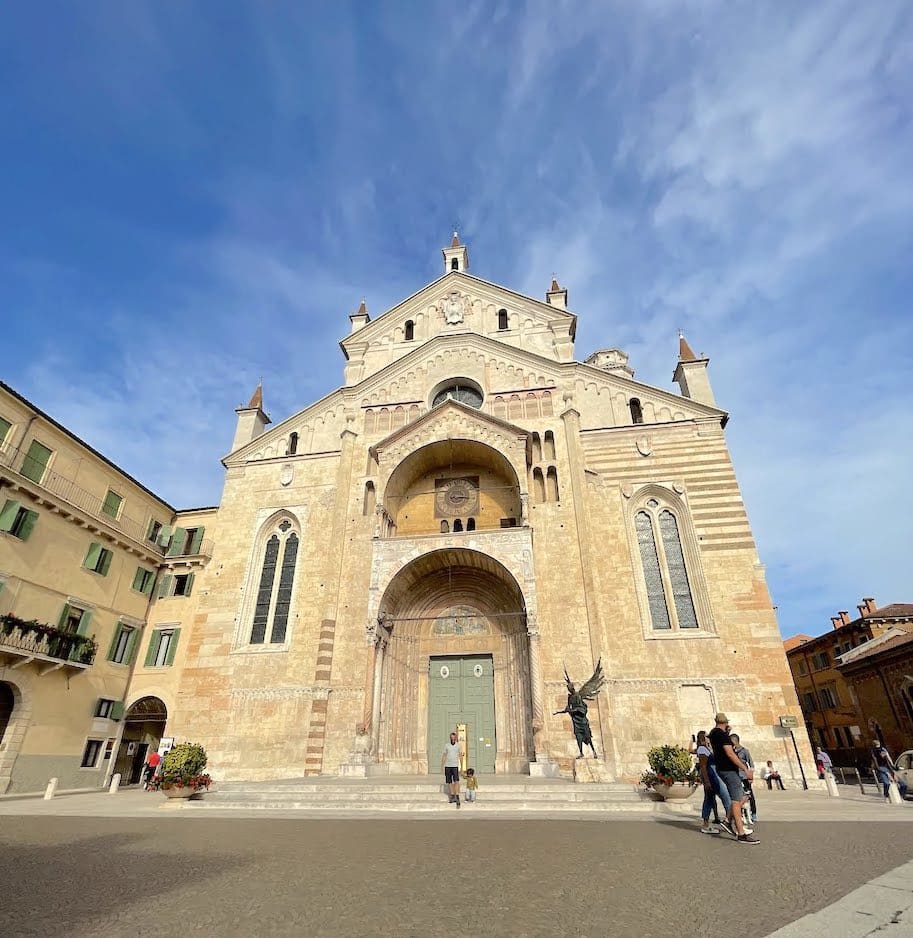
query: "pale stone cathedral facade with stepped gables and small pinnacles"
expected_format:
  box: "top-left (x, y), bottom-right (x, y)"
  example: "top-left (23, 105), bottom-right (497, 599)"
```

top-left (126, 235), bottom-right (799, 779)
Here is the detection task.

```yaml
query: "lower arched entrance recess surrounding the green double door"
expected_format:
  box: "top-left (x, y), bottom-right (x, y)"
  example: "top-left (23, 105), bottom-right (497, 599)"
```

top-left (375, 548), bottom-right (533, 772)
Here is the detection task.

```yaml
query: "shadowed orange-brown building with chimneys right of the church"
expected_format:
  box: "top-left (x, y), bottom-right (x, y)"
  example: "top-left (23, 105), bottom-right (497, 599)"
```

top-left (784, 597), bottom-right (913, 766)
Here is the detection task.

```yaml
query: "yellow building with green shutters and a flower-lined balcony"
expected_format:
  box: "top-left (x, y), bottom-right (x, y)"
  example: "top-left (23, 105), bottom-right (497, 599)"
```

top-left (0, 383), bottom-right (206, 793)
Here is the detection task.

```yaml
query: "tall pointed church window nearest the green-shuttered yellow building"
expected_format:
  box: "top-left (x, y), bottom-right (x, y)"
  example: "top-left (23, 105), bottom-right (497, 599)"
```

top-left (248, 517), bottom-right (300, 645)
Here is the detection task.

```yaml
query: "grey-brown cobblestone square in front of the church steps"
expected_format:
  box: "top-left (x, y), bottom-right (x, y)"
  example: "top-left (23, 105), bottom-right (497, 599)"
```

top-left (0, 808), bottom-right (913, 938)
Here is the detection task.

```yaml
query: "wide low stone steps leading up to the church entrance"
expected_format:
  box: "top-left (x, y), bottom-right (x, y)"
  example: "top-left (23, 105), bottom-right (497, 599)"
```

top-left (186, 775), bottom-right (664, 816)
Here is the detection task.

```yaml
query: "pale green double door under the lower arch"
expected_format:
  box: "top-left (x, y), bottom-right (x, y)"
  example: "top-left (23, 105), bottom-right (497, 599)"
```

top-left (428, 655), bottom-right (497, 775)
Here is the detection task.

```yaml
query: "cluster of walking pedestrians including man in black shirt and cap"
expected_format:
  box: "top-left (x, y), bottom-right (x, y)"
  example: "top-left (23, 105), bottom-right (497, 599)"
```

top-left (696, 713), bottom-right (760, 844)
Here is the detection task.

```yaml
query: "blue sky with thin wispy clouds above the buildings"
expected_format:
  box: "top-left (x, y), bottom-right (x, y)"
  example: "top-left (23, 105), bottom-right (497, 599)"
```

top-left (0, 0), bottom-right (913, 635)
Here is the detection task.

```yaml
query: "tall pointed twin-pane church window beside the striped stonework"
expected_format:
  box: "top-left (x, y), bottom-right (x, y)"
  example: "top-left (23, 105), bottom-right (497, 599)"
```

top-left (634, 497), bottom-right (702, 633)
